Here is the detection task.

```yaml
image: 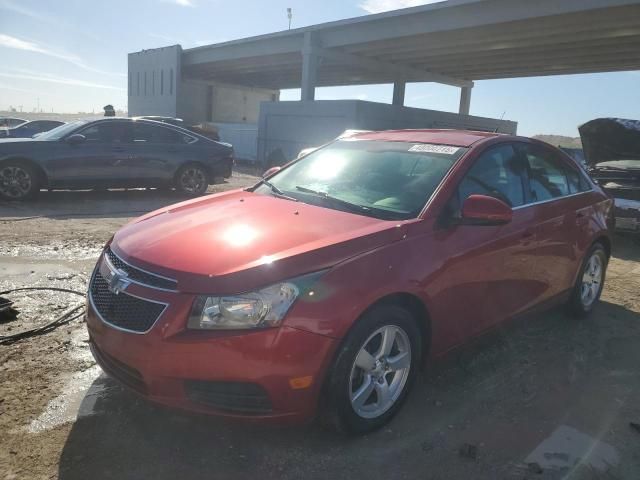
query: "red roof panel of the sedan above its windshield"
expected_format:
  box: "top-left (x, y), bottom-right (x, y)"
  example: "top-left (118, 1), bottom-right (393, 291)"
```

top-left (351, 129), bottom-right (504, 147)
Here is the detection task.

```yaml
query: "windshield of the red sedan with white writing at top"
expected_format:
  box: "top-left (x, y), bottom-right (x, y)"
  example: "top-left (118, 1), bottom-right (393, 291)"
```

top-left (255, 140), bottom-right (467, 219)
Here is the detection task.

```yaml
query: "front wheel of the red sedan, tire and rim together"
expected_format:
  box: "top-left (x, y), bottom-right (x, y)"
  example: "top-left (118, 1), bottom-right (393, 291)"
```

top-left (323, 305), bottom-right (422, 435)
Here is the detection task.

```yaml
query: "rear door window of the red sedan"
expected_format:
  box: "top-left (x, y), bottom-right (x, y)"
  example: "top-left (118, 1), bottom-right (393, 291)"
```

top-left (522, 145), bottom-right (568, 202)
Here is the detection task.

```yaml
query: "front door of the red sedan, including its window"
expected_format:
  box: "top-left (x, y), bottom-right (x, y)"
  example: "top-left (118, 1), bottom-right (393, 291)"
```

top-left (435, 143), bottom-right (540, 340)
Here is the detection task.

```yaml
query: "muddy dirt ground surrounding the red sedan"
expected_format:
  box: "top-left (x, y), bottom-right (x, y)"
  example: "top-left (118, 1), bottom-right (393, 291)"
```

top-left (0, 174), bottom-right (640, 480)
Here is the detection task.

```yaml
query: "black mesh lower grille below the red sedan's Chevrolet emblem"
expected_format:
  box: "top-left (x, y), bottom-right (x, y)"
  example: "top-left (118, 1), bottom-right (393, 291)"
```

top-left (89, 271), bottom-right (166, 333)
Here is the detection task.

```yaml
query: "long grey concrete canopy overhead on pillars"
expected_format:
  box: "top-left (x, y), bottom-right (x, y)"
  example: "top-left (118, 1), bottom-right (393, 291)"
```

top-left (182, 0), bottom-right (640, 92)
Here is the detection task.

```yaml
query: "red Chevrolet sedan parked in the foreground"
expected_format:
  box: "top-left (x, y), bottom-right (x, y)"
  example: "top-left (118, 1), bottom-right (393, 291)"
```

top-left (87, 130), bottom-right (613, 433)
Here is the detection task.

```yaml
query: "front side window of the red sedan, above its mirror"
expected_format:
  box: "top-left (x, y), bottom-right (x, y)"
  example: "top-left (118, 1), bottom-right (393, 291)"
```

top-left (458, 144), bottom-right (525, 207)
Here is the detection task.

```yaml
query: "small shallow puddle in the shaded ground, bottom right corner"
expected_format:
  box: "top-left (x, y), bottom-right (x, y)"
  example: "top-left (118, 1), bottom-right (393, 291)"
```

top-left (525, 425), bottom-right (620, 471)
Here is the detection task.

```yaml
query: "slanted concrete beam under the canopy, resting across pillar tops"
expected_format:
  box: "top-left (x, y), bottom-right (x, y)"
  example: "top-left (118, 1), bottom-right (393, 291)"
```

top-left (316, 47), bottom-right (473, 87)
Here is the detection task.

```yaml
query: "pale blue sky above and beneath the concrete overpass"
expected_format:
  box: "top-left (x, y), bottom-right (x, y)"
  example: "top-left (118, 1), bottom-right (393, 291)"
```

top-left (0, 0), bottom-right (640, 136)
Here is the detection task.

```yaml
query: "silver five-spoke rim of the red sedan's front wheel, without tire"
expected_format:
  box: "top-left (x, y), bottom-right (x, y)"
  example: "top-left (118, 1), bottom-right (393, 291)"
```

top-left (349, 325), bottom-right (411, 418)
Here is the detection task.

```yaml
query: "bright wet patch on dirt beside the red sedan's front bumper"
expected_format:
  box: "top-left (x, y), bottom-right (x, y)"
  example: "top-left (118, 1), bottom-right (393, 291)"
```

top-left (26, 328), bottom-right (115, 433)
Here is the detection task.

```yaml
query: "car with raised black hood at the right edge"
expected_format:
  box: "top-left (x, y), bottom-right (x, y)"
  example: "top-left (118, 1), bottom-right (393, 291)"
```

top-left (579, 118), bottom-right (640, 237)
